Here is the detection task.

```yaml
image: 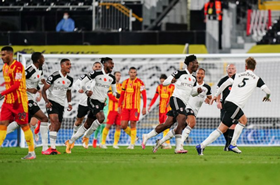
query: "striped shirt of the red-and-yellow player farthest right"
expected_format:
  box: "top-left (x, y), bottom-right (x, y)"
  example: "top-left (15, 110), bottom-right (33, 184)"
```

top-left (150, 84), bottom-right (175, 113)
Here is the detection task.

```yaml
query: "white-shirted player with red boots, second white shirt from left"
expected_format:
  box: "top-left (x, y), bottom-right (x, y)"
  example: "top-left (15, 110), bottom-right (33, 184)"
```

top-left (42, 59), bottom-right (73, 155)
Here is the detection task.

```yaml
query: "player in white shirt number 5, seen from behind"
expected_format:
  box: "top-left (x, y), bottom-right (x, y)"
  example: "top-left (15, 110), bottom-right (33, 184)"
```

top-left (196, 57), bottom-right (271, 155)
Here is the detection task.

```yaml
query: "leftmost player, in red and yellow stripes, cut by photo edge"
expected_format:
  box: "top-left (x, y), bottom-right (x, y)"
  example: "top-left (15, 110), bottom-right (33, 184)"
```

top-left (0, 46), bottom-right (36, 159)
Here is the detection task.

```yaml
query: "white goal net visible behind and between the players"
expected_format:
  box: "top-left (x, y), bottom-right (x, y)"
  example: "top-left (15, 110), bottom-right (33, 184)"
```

top-left (18, 53), bottom-right (280, 147)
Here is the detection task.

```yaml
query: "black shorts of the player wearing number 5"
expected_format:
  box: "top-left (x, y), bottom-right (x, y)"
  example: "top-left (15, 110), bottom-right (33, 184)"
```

top-left (222, 102), bottom-right (244, 127)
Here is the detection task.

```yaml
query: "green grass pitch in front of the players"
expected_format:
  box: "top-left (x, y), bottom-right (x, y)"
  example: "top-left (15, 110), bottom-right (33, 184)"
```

top-left (0, 146), bottom-right (280, 185)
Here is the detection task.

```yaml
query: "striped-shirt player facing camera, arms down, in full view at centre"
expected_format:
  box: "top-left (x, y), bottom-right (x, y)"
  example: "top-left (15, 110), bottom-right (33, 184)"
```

top-left (118, 67), bottom-right (147, 149)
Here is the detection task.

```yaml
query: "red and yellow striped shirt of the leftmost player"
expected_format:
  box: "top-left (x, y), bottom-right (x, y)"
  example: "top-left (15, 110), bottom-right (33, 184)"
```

top-left (1, 60), bottom-right (28, 110)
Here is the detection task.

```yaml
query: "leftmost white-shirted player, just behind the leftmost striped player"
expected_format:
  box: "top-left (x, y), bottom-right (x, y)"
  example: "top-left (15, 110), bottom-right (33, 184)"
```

top-left (7, 52), bottom-right (48, 152)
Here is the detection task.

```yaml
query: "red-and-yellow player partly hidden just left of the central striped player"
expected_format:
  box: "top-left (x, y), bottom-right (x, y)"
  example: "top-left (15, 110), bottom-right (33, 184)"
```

top-left (100, 71), bottom-right (122, 149)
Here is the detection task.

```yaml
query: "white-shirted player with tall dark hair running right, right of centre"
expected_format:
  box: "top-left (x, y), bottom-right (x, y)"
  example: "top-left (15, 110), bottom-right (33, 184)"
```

top-left (142, 55), bottom-right (201, 153)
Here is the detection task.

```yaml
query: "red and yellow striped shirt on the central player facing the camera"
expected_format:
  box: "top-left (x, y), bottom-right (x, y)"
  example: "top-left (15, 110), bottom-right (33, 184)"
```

top-left (119, 77), bottom-right (146, 111)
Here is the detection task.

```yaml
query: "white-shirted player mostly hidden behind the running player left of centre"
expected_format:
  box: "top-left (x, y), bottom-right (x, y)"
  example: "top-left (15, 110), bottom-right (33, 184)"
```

top-left (72, 62), bottom-right (101, 148)
